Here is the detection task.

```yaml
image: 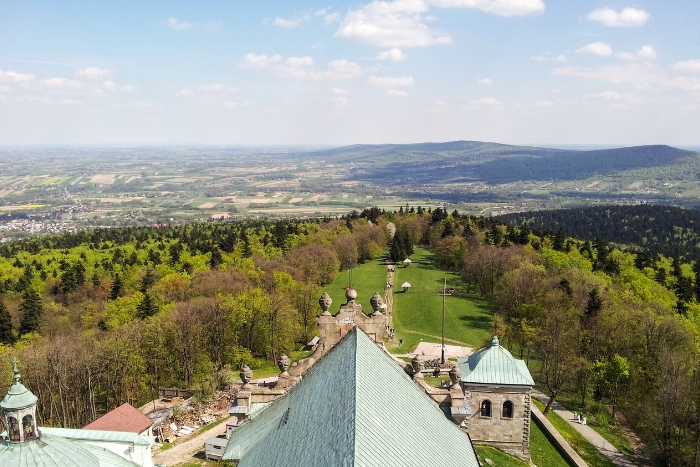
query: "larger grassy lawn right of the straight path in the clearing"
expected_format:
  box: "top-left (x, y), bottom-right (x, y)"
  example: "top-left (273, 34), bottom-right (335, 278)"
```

top-left (387, 248), bottom-right (493, 353)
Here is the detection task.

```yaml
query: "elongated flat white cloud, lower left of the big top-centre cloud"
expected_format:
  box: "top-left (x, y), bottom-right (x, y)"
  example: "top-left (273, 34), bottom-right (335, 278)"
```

top-left (238, 53), bottom-right (363, 80)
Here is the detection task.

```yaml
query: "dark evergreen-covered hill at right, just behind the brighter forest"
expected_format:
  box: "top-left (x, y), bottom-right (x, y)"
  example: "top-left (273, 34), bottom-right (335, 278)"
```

top-left (498, 205), bottom-right (700, 259)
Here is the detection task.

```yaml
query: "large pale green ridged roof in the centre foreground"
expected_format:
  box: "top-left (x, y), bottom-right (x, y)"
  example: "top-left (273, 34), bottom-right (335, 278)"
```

top-left (224, 327), bottom-right (479, 467)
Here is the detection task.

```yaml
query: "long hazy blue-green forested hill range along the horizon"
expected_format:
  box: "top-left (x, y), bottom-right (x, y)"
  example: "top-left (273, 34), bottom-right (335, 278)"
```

top-left (310, 141), bottom-right (700, 184)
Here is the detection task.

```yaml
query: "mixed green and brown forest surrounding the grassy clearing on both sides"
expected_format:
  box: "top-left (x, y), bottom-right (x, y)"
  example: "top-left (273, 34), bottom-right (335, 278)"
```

top-left (0, 207), bottom-right (700, 466)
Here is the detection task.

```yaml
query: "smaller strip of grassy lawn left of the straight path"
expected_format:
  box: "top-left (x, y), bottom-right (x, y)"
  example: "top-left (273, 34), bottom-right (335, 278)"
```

top-left (323, 259), bottom-right (386, 314)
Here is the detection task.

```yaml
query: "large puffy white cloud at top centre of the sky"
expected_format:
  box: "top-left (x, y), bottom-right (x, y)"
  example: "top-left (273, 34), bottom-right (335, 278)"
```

top-left (335, 0), bottom-right (452, 47)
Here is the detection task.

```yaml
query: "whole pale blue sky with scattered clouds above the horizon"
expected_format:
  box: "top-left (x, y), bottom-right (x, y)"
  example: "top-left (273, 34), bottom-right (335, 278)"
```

top-left (0, 0), bottom-right (700, 146)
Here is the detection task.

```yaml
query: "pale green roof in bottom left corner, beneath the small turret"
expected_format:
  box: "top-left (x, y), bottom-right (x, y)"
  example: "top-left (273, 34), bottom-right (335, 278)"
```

top-left (0, 433), bottom-right (137, 467)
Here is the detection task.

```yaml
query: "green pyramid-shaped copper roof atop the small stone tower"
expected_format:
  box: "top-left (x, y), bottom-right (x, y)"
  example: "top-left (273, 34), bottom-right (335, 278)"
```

top-left (457, 336), bottom-right (535, 386)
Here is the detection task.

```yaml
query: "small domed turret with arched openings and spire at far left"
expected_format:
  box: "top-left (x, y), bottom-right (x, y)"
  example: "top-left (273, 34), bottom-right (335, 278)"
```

top-left (0, 359), bottom-right (39, 443)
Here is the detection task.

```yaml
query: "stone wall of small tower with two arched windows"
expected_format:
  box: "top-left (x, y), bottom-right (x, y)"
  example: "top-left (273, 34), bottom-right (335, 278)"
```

top-left (462, 383), bottom-right (531, 461)
